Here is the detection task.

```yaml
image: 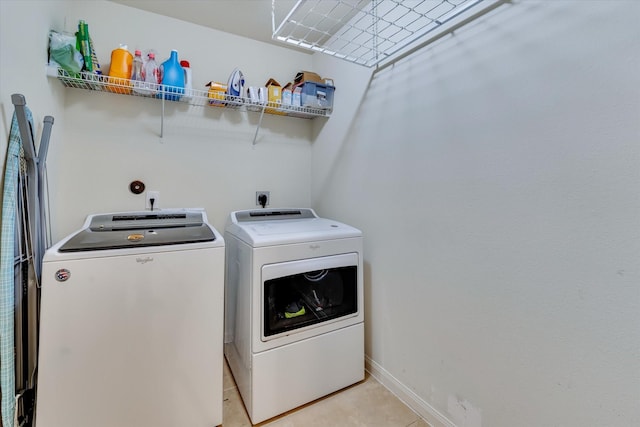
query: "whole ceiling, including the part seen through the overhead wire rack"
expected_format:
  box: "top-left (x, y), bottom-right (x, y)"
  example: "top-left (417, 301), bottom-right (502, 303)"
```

top-left (110, 0), bottom-right (492, 66)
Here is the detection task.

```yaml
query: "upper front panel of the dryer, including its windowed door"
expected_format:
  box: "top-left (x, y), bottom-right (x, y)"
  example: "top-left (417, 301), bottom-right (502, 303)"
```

top-left (249, 237), bottom-right (364, 354)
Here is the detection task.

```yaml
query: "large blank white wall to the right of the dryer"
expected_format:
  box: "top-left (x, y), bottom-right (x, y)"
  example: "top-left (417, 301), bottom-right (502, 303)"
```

top-left (312, 1), bottom-right (640, 427)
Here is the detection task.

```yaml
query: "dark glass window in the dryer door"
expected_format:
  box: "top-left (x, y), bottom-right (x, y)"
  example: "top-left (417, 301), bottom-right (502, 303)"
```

top-left (263, 256), bottom-right (358, 339)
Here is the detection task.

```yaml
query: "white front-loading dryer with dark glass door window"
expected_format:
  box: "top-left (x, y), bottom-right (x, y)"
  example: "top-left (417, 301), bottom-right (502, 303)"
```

top-left (225, 209), bottom-right (364, 424)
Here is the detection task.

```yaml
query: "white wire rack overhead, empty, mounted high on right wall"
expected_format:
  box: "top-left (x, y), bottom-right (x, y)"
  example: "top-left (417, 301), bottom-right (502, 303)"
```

top-left (272, 0), bottom-right (483, 67)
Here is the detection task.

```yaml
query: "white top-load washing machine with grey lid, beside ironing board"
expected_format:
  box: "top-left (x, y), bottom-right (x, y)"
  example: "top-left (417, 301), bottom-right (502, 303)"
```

top-left (35, 209), bottom-right (224, 427)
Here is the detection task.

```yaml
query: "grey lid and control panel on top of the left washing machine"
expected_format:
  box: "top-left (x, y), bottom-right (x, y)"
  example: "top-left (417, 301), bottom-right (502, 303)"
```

top-left (58, 211), bottom-right (216, 252)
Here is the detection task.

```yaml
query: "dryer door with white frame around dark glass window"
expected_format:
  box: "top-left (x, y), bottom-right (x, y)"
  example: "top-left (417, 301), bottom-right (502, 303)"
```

top-left (261, 253), bottom-right (359, 341)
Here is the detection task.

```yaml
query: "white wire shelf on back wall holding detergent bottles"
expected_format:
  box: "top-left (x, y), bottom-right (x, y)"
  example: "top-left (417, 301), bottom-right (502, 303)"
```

top-left (53, 68), bottom-right (331, 119)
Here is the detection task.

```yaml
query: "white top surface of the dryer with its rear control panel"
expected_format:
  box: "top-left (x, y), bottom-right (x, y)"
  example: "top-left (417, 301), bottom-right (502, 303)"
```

top-left (226, 209), bottom-right (362, 247)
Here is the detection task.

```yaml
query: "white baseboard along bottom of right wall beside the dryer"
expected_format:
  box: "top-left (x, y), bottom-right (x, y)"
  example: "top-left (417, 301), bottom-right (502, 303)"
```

top-left (364, 356), bottom-right (456, 427)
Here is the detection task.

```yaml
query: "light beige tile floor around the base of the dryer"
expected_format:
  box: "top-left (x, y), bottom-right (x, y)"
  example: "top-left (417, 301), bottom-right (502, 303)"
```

top-left (222, 361), bottom-right (429, 427)
